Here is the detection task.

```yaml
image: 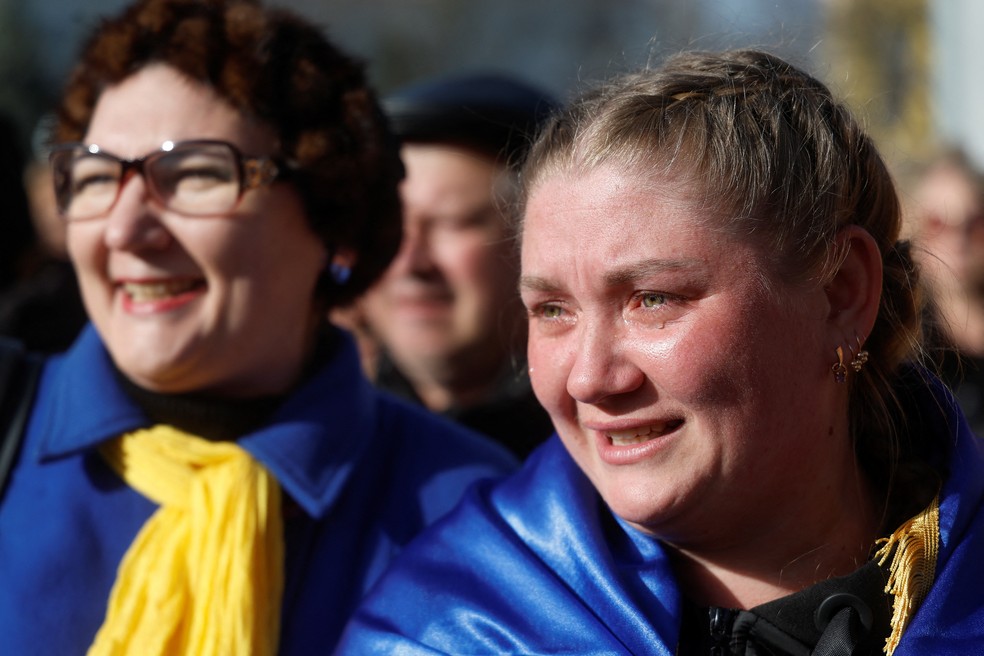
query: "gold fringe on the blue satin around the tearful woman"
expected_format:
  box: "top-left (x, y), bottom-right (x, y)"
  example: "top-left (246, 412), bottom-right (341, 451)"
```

top-left (875, 497), bottom-right (940, 656)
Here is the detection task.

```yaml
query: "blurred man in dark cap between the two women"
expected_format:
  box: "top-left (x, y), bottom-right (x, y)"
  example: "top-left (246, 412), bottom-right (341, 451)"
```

top-left (361, 74), bottom-right (557, 457)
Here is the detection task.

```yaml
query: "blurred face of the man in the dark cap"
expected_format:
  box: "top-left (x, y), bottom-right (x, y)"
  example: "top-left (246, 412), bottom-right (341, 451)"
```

top-left (364, 144), bottom-right (519, 379)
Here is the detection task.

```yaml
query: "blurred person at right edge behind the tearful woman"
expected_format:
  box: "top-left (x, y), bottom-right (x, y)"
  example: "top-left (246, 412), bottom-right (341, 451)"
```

top-left (907, 148), bottom-right (984, 434)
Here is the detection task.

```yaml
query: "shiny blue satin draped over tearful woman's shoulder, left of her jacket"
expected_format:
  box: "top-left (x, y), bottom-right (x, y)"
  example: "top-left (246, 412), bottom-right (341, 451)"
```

top-left (339, 439), bottom-right (684, 654)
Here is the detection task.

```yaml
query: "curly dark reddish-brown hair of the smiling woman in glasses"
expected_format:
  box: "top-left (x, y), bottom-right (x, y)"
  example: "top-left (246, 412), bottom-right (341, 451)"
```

top-left (55, 0), bottom-right (403, 306)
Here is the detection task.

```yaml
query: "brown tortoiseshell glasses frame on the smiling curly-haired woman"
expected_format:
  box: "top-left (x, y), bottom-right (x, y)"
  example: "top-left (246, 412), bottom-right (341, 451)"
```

top-left (48, 139), bottom-right (288, 223)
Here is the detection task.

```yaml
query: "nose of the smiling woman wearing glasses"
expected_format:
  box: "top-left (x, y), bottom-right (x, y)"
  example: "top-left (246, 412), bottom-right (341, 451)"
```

top-left (104, 175), bottom-right (171, 251)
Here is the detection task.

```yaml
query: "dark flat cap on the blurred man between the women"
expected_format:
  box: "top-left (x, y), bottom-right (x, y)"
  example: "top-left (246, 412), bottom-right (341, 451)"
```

top-left (383, 74), bottom-right (559, 163)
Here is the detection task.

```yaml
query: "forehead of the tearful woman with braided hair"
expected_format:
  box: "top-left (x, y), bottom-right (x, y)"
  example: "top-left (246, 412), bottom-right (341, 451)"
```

top-left (522, 167), bottom-right (769, 286)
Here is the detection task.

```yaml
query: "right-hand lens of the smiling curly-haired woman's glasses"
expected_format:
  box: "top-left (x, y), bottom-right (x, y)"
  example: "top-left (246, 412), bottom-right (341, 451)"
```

top-left (151, 144), bottom-right (240, 216)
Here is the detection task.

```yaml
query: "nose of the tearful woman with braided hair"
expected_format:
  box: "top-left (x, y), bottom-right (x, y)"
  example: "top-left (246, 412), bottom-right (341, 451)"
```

top-left (567, 321), bottom-right (646, 405)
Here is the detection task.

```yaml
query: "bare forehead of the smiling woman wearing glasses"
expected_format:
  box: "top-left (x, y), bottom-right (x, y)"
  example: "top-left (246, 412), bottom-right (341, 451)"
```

top-left (84, 64), bottom-right (275, 157)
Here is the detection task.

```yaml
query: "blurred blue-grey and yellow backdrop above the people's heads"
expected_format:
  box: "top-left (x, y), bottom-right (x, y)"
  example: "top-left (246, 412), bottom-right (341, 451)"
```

top-left (0, 0), bottom-right (984, 188)
